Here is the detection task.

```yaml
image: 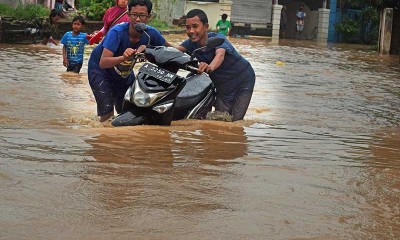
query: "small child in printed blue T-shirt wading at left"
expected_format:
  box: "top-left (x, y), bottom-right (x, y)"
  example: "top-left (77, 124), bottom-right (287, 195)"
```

top-left (61, 16), bottom-right (89, 73)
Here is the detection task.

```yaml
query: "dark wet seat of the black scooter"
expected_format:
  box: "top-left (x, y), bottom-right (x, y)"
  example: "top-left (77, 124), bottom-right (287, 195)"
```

top-left (175, 74), bottom-right (213, 109)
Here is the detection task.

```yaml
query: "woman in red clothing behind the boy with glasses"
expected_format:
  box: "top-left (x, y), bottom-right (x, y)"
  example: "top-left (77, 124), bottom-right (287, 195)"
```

top-left (89, 0), bottom-right (130, 44)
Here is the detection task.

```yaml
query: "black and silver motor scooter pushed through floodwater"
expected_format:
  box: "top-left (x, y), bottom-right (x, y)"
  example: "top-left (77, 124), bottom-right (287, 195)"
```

top-left (111, 23), bottom-right (224, 126)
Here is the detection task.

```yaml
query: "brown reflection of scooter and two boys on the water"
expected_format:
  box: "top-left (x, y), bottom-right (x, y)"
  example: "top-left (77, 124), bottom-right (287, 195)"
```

top-left (87, 121), bottom-right (247, 166)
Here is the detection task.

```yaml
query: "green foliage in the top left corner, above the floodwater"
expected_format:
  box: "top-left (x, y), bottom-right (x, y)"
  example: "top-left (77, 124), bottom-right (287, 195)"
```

top-left (0, 4), bottom-right (50, 20)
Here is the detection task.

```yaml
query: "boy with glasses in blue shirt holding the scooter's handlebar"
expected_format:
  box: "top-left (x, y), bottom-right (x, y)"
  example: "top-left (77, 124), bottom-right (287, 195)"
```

top-left (88, 0), bottom-right (170, 122)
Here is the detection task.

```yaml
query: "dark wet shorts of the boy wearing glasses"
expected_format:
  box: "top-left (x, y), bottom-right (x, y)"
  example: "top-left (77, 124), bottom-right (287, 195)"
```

top-left (88, 69), bottom-right (129, 116)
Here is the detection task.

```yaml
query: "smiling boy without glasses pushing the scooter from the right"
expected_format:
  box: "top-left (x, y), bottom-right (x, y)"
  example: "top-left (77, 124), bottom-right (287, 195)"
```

top-left (177, 9), bottom-right (256, 121)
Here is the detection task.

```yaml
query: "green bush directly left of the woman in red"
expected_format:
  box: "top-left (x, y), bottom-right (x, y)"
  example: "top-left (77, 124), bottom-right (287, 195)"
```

top-left (77, 0), bottom-right (115, 21)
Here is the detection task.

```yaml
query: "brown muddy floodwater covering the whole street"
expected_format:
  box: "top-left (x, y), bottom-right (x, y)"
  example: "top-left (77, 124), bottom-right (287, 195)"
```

top-left (0, 35), bottom-right (400, 239)
